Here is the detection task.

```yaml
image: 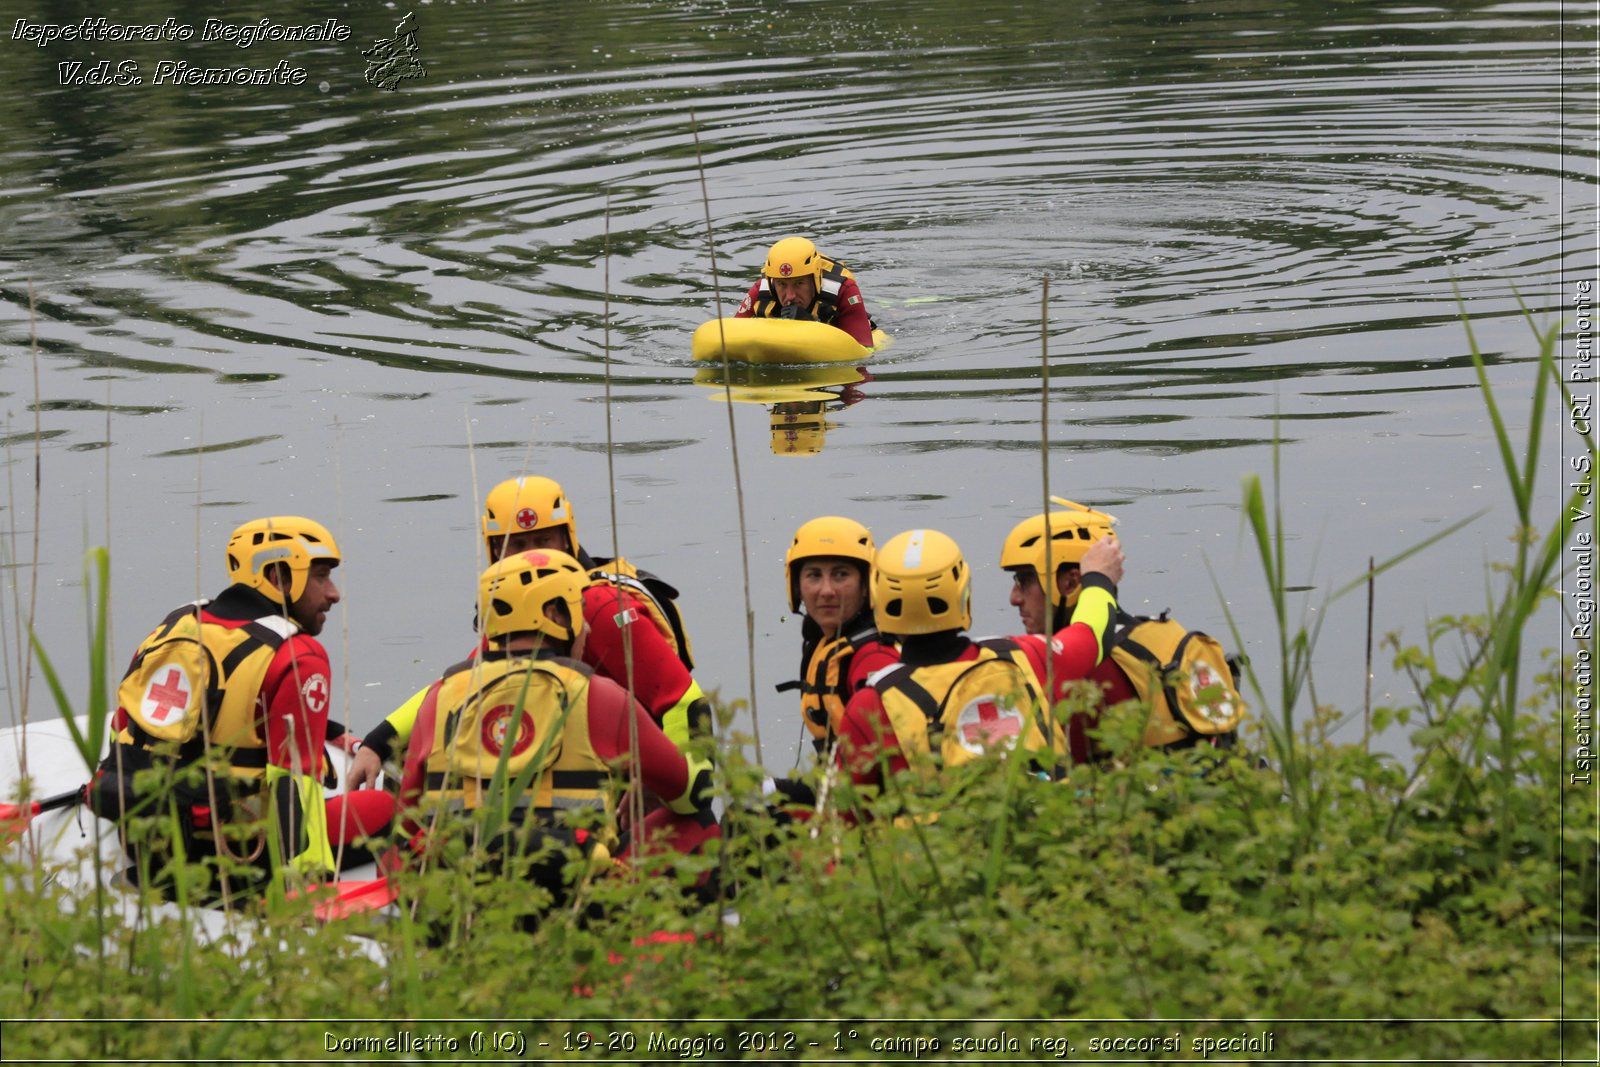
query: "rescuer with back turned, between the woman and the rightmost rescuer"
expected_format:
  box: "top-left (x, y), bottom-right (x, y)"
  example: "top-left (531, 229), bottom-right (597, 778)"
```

top-left (838, 530), bottom-right (1123, 799)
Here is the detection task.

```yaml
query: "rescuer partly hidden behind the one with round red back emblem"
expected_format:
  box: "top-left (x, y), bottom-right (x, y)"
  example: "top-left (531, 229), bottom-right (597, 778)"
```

top-left (346, 477), bottom-right (710, 790)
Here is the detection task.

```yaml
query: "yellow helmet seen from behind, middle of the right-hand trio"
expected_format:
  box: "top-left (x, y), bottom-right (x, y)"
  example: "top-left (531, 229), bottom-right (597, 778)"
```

top-left (872, 530), bottom-right (973, 633)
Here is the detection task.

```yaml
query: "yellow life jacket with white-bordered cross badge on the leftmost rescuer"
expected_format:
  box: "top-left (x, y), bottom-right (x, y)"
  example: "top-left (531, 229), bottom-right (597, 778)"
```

top-left (117, 600), bottom-right (298, 776)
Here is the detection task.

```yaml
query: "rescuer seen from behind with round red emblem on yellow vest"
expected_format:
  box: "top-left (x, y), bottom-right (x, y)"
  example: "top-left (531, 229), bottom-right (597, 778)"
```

top-left (390, 549), bottom-right (717, 910)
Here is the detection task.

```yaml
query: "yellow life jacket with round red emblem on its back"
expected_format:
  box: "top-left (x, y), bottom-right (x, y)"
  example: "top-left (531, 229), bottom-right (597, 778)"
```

top-left (422, 656), bottom-right (610, 814)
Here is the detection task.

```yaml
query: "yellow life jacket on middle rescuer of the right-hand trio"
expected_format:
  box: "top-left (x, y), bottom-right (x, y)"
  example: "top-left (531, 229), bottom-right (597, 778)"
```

top-left (872, 637), bottom-right (1066, 777)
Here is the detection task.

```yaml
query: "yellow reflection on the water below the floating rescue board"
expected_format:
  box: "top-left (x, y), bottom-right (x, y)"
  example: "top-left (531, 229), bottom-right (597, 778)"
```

top-left (694, 363), bottom-right (872, 456)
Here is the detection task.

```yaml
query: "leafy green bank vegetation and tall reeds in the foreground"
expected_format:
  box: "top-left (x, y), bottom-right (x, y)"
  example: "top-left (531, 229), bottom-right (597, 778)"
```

top-left (0, 321), bottom-right (1600, 1062)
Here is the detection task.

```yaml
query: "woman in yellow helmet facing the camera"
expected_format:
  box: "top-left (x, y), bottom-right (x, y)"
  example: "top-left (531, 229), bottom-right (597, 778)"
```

top-left (779, 515), bottom-right (898, 755)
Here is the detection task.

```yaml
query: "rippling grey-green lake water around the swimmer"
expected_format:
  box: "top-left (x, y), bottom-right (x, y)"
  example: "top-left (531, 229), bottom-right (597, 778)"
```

top-left (0, 0), bottom-right (1597, 765)
